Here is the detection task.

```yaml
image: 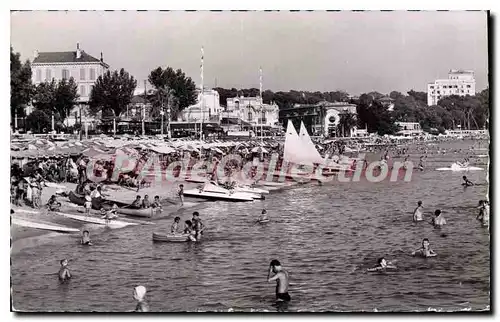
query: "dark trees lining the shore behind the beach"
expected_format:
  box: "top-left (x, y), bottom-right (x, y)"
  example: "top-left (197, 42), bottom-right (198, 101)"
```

top-left (10, 47), bottom-right (490, 135)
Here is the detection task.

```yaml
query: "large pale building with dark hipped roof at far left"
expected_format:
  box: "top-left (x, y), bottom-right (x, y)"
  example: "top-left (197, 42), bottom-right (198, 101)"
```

top-left (30, 44), bottom-right (109, 126)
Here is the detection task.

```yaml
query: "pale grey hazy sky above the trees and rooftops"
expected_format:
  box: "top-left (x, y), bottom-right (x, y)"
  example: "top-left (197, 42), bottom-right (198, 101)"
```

top-left (11, 11), bottom-right (488, 95)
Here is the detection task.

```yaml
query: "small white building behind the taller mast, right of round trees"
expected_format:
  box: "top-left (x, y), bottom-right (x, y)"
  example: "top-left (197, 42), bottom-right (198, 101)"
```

top-left (181, 89), bottom-right (223, 122)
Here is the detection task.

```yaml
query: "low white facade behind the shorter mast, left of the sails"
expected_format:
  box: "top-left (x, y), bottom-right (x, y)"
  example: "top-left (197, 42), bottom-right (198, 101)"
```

top-left (222, 97), bottom-right (279, 126)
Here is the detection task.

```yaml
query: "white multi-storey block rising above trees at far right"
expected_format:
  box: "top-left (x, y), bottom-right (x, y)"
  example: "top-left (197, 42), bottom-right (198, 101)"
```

top-left (427, 69), bottom-right (476, 106)
